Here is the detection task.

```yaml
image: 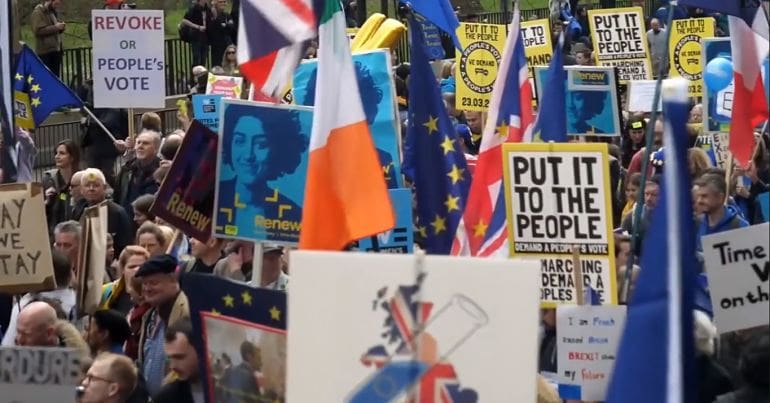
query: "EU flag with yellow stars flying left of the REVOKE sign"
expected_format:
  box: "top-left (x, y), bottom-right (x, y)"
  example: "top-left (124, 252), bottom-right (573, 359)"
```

top-left (13, 45), bottom-right (83, 129)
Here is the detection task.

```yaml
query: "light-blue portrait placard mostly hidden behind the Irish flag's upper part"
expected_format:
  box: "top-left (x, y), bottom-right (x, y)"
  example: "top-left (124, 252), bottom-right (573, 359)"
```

top-left (293, 49), bottom-right (404, 189)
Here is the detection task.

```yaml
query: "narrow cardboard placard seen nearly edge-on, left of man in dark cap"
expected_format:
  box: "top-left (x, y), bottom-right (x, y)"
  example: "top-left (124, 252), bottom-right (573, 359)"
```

top-left (76, 201), bottom-right (108, 316)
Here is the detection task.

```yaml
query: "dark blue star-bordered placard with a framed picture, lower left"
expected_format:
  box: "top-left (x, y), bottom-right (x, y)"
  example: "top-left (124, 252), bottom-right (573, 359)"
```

top-left (180, 273), bottom-right (286, 403)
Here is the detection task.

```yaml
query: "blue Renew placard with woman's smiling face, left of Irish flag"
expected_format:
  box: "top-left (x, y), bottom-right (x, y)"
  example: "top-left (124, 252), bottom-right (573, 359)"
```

top-left (214, 99), bottom-right (313, 245)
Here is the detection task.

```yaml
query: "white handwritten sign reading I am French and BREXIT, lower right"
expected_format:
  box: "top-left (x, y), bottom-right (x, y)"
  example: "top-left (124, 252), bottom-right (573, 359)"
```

top-left (556, 305), bottom-right (626, 401)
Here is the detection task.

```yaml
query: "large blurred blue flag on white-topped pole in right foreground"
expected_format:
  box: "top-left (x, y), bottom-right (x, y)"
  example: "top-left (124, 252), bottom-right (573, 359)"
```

top-left (606, 79), bottom-right (697, 403)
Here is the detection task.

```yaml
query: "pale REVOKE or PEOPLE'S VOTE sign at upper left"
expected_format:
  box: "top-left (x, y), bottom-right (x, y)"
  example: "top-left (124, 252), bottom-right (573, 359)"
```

top-left (91, 10), bottom-right (166, 108)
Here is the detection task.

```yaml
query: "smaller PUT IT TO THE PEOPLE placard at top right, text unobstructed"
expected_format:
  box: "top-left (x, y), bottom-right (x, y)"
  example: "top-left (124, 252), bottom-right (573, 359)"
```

top-left (588, 7), bottom-right (652, 83)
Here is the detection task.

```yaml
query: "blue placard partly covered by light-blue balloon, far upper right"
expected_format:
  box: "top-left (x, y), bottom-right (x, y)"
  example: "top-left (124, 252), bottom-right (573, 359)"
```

top-left (701, 38), bottom-right (770, 133)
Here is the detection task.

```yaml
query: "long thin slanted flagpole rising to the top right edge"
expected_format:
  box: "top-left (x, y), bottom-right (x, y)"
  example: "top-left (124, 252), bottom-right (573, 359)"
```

top-left (620, 0), bottom-right (679, 303)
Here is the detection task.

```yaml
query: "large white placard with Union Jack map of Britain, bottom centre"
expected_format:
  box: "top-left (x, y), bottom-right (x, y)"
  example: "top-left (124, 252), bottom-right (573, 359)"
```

top-left (286, 251), bottom-right (539, 403)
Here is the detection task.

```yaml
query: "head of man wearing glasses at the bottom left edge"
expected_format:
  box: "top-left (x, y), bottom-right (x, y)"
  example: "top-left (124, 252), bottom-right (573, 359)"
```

top-left (78, 353), bottom-right (137, 403)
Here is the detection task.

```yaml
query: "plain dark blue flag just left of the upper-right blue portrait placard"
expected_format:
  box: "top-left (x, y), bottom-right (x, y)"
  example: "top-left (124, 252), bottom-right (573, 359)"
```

top-left (535, 32), bottom-right (569, 143)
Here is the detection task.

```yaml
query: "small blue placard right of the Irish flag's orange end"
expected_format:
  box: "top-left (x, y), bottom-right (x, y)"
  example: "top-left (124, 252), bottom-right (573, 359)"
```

top-left (358, 189), bottom-right (414, 253)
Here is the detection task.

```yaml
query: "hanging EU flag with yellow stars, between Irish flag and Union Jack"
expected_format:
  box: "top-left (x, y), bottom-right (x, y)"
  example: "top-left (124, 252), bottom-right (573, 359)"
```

top-left (403, 17), bottom-right (471, 254)
